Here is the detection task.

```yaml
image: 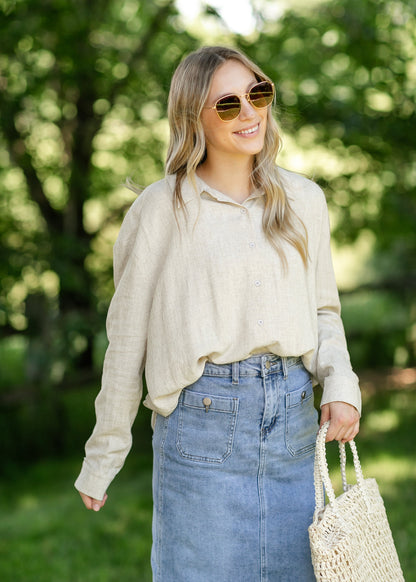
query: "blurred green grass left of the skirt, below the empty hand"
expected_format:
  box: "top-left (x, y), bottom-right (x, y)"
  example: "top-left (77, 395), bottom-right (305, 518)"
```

top-left (0, 457), bottom-right (151, 582)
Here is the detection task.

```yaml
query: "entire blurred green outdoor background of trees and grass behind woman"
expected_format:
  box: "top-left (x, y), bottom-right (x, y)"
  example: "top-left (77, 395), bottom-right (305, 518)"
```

top-left (0, 0), bottom-right (416, 582)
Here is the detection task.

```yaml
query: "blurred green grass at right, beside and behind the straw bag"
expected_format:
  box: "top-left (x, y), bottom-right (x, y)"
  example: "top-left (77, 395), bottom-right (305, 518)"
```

top-left (328, 389), bottom-right (416, 582)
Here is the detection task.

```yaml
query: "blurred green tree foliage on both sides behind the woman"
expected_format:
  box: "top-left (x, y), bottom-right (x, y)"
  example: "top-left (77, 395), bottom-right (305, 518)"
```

top-left (0, 0), bottom-right (416, 466)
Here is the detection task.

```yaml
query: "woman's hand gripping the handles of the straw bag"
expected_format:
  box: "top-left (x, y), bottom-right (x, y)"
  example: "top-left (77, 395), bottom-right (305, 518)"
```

top-left (320, 402), bottom-right (360, 443)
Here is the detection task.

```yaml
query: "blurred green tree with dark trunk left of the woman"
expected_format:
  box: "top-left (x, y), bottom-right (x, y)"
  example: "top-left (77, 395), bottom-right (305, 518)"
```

top-left (0, 0), bottom-right (196, 392)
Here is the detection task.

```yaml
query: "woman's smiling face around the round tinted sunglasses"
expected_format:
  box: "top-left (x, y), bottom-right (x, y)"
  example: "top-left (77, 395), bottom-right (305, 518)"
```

top-left (201, 60), bottom-right (268, 163)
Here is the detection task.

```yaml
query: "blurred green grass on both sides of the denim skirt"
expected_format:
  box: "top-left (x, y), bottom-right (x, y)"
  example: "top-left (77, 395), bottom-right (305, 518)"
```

top-left (0, 376), bottom-right (416, 582)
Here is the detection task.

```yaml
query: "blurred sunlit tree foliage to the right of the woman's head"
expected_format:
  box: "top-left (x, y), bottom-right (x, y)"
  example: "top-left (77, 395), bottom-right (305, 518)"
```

top-left (239, 0), bottom-right (416, 365)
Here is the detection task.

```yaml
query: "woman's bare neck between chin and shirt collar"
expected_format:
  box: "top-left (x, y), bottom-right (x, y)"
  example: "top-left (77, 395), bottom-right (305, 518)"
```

top-left (197, 156), bottom-right (253, 203)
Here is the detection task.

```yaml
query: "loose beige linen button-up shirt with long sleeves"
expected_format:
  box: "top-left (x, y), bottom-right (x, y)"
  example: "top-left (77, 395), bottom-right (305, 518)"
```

top-left (75, 169), bottom-right (361, 499)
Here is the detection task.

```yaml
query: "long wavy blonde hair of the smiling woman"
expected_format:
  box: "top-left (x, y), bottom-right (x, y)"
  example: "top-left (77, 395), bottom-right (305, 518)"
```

top-left (166, 46), bottom-right (308, 268)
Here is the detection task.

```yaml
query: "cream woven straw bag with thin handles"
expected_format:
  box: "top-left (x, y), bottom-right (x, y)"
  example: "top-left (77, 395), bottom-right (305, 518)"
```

top-left (309, 422), bottom-right (404, 582)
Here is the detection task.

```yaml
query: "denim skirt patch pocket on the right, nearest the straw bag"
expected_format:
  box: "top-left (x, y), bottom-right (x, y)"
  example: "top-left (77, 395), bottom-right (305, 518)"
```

top-left (285, 380), bottom-right (318, 457)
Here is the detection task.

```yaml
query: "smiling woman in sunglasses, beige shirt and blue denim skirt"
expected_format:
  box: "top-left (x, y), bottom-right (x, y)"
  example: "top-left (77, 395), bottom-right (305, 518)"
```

top-left (76, 47), bottom-right (360, 582)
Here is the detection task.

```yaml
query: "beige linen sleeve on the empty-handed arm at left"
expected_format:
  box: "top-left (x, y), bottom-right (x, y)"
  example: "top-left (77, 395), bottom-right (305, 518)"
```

top-left (75, 198), bottom-right (165, 499)
